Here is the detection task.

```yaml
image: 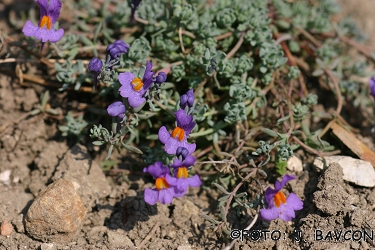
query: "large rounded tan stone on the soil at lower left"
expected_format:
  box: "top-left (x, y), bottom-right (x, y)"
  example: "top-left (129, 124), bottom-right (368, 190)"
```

top-left (25, 179), bottom-right (86, 243)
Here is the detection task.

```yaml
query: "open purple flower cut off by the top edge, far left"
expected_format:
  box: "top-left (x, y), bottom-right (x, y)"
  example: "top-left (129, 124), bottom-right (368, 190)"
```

top-left (22, 0), bottom-right (64, 43)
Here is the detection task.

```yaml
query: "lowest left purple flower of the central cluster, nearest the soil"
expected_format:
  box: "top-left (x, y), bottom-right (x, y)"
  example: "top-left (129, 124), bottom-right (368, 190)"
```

top-left (143, 162), bottom-right (175, 205)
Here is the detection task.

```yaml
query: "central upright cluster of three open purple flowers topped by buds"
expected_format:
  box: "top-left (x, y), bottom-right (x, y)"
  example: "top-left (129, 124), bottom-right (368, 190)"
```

top-left (143, 89), bottom-right (202, 205)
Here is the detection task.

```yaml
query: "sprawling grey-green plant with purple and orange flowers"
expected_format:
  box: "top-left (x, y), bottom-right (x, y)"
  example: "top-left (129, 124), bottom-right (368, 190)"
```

top-left (10, 0), bottom-right (375, 247)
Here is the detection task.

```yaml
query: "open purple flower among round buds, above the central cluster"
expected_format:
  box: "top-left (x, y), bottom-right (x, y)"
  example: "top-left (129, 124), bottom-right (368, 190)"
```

top-left (118, 62), bottom-right (154, 108)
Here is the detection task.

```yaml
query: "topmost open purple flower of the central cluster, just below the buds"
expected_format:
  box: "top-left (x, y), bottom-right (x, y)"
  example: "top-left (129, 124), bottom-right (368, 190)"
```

top-left (158, 109), bottom-right (196, 154)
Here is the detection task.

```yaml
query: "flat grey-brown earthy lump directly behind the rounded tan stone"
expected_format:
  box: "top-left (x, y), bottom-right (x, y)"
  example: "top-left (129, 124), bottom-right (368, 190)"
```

top-left (52, 145), bottom-right (111, 212)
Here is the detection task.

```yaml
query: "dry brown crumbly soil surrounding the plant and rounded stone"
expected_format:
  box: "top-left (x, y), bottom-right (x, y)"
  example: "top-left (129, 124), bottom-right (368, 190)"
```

top-left (0, 0), bottom-right (375, 250)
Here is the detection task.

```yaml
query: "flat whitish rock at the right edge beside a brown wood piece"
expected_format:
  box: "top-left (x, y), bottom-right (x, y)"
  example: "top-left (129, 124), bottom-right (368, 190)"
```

top-left (314, 155), bottom-right (375, 187)
